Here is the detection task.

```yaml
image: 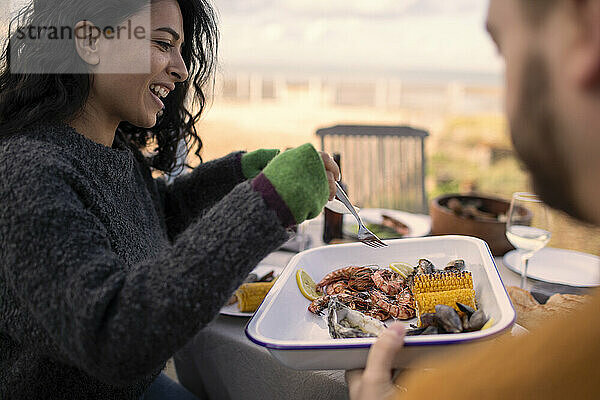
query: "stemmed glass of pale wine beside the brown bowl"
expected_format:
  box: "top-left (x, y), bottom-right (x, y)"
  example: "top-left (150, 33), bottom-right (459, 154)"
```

top-left (506, 192), bottom-right (552, 289)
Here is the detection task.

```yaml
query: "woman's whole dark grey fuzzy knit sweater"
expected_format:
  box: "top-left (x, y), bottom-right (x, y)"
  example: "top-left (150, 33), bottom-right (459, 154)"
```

top-left (0, 124), bottom-right (288, 400)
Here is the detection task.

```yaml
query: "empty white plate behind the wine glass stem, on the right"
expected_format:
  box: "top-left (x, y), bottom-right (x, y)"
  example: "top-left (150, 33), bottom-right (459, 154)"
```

top-left (502, 247), bottom-right (600, 287)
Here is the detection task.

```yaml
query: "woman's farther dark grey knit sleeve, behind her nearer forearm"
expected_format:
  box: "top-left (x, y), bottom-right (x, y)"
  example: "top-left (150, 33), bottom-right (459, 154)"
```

top-left (156, 152), bottom-right (245, 238)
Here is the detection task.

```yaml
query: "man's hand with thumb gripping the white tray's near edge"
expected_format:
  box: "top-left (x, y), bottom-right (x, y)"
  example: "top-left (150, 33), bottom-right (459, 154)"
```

top-left (346, 322), bottom-right (405, 400)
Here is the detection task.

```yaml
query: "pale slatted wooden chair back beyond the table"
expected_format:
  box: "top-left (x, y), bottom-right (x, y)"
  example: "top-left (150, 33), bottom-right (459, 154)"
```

top-left (317, 125), bottom-right (429, 214)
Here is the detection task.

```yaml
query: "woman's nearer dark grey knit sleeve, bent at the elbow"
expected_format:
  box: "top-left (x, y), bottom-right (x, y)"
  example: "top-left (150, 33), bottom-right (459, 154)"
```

top-left (0, 159), bottom-right (287, 384)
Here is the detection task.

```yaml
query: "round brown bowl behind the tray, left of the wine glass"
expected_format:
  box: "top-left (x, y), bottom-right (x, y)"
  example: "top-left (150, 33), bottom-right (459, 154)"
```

top-left (429, 194), bottom-right (527, 257)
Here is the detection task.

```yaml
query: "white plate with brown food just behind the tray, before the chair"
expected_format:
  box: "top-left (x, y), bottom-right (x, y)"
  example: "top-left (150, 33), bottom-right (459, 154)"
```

top-left (343, 208), bottom-right (431, 238)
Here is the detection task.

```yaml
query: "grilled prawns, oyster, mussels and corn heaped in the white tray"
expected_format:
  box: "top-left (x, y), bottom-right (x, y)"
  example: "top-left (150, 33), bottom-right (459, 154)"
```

top-left (298, 258), bottom-right (487, 339)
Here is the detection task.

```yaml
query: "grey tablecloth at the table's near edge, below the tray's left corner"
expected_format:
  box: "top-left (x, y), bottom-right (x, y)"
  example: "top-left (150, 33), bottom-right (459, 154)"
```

top-left (174, 316), bottom-right (347, 400)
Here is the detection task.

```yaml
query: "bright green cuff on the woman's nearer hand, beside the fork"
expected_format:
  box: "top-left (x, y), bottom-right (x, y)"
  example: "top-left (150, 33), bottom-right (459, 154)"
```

top-left (257, 143), bottom-right (329, 224)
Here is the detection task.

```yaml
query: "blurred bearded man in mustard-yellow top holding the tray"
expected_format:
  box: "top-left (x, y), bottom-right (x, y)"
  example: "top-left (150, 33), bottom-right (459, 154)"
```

top-left (347, 0), bottom-right (600, 400)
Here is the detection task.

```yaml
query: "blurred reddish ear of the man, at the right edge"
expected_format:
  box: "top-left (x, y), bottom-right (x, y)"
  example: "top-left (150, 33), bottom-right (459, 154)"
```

top-left (571, 0), bottom-right (600, 88)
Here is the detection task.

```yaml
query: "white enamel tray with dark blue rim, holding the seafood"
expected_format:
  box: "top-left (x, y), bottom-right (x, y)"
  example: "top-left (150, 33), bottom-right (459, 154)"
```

top-left (246, 236), bottom-right (515, 369)
